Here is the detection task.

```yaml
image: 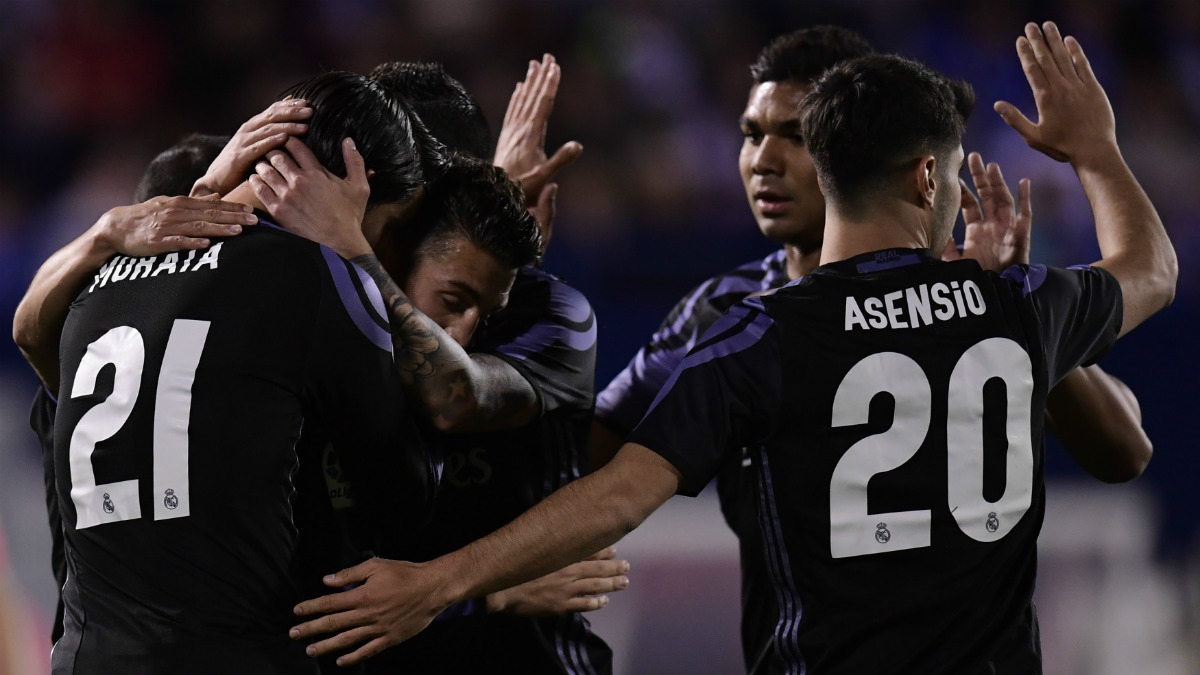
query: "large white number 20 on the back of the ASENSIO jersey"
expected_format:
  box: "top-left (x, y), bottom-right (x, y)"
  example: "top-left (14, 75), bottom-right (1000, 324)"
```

top-left (829, 338), bottom-right (1033, 557)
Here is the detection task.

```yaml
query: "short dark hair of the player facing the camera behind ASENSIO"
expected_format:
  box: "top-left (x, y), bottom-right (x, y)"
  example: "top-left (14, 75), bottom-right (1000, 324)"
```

top-left (750, 25), bottom-right (875, 84)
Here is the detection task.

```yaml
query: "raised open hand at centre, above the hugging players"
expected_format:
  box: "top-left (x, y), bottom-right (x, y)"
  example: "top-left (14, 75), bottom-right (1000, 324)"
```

top-left (492, 54), bottom-right (583, 250)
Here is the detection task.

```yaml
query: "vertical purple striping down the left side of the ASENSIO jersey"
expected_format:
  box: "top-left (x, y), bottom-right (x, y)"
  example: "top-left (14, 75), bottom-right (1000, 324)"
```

top-left (758, 447), bottom-right (808, 675)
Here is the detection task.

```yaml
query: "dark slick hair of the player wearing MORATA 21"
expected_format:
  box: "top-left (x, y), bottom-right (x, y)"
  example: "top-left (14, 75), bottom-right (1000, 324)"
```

top-left (280, 71), bottom-right (442, 204)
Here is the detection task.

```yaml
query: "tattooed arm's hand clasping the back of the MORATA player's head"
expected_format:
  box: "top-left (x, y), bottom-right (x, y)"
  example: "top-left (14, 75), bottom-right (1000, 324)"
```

top-left (250, 137), bottom-right (371, 259)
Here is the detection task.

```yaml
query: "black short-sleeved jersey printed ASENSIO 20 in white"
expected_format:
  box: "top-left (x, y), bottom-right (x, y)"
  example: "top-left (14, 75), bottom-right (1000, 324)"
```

top-left (631, 250), bottom-right (1121, 674)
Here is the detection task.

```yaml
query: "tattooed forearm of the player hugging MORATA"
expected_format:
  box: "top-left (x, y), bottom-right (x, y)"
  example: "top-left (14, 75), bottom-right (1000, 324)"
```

top-left (353, 255), bottom-right (538, 431)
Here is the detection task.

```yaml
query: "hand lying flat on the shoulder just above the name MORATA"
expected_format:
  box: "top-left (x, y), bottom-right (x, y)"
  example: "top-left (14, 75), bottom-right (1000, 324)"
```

top-left (95, 195), bottom-right (258, 257)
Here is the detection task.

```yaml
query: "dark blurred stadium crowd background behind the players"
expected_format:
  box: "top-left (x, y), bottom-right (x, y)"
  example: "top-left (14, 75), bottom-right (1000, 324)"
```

top-left (0, 0), bottom-right (1200, 673)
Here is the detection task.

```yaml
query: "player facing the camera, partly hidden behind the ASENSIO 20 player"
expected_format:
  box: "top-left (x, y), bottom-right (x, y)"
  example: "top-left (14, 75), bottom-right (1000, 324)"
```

top-left (592, 26), bottom-right (1151, 671)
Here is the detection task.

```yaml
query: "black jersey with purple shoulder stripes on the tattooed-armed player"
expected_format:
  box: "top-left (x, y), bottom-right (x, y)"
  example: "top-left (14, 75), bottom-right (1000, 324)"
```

top-left (381, 267), bottom-right (612, 674)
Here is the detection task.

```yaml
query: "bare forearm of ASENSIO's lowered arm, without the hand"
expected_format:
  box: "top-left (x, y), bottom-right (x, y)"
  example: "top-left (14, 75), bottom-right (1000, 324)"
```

top-left (431, 444), bottom-right (680, 603)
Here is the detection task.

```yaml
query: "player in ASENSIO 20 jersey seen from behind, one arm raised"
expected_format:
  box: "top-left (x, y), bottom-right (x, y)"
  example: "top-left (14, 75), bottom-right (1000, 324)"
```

top-left (292, 22), bottom-right (1177, 673)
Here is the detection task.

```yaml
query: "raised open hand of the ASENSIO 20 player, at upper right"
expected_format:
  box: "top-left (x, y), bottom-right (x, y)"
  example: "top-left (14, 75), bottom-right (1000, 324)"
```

top-left (995, 22), bottom-right (1116, 166)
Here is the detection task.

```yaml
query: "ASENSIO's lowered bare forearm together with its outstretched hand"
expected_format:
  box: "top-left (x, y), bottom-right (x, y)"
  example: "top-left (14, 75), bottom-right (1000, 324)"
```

top-left (289, 443), bottom-right (683, 665)
